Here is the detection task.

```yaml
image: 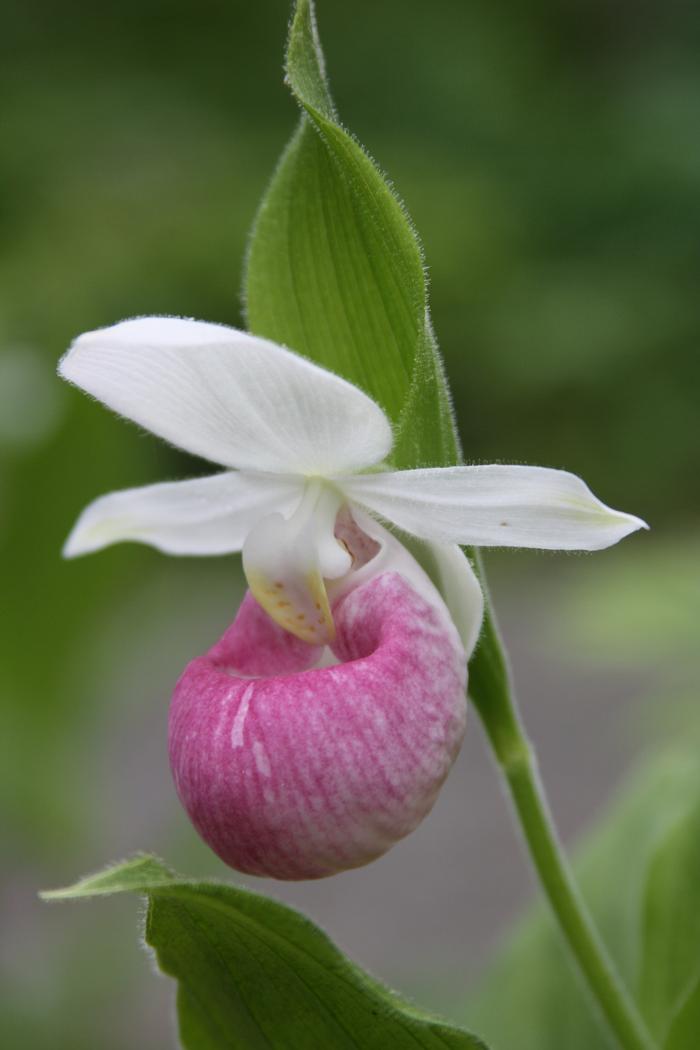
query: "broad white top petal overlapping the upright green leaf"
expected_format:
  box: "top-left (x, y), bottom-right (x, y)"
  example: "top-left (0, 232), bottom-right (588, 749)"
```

top-left (59, 317), bottom-right (391, 476)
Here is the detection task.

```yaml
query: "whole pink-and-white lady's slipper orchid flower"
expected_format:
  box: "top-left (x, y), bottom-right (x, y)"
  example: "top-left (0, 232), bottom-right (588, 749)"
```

top-left (59, 317), bottom-right (643, 878)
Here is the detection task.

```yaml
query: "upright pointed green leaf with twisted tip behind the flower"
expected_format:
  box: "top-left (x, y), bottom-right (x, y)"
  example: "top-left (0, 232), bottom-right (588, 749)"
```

top-left (246, 0), bottom-right (459, 467)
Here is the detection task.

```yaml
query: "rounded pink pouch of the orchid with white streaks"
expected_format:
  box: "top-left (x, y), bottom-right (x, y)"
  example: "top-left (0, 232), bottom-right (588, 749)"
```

top-left (170, 571), bottom-right (466, 879)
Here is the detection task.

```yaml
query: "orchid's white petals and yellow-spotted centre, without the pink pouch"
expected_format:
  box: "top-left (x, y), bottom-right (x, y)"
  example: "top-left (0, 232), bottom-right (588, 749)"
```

top-left (59, 317), bottom-right (643, 642)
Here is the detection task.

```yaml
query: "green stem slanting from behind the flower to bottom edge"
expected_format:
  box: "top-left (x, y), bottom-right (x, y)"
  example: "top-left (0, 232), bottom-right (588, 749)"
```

top-left (470, 562), bottom-right (656, 1050)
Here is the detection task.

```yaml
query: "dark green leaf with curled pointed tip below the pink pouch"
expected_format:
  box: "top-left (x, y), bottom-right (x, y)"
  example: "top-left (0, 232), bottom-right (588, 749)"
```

top-left (42, 856), bottom-right (485, 1050)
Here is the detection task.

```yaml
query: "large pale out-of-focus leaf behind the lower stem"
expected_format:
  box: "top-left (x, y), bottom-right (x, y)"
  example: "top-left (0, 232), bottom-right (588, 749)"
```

top-left (464, 751), bottom-right (700, 1050)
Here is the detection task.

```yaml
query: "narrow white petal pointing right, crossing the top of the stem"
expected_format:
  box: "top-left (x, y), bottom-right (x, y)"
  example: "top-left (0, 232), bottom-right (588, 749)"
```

top-left (338, 464), bottom-right (646, 550)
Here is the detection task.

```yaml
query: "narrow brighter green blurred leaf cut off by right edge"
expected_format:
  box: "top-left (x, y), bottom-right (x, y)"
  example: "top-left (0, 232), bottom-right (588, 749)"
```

top-left (639, 805), bottom-right (700, 1033)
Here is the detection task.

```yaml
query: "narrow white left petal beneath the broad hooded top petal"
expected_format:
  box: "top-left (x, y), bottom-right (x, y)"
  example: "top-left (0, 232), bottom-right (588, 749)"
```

top-left (63, 471), bottom-right (301, 558)
